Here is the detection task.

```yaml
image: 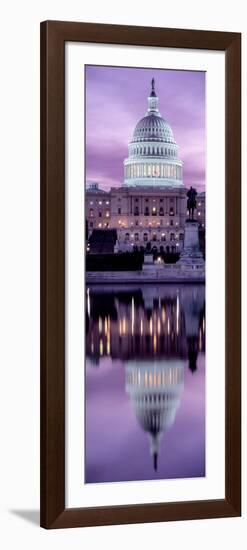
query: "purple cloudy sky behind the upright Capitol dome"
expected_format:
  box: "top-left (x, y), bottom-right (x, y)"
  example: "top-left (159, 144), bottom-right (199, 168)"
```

top-left (86, 66), bottom-right (205, 190)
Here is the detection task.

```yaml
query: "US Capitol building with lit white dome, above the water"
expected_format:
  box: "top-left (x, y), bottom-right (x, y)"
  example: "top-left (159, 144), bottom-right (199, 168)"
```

top-left (86, 79), bottom-right (205, 252)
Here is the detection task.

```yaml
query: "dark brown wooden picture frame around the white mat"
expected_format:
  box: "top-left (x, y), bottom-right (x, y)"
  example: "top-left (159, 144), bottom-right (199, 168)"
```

top-left (41, 21), bottom-right (241, 528)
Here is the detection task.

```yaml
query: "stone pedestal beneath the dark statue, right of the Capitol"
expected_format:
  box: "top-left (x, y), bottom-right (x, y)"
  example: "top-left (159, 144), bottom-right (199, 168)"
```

top-left (177, 220), bottom-right (205, 266)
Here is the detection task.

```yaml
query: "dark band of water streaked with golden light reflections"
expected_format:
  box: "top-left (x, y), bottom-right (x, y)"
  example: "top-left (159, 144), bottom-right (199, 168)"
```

top-left (86, 289), bottom-right (205, 364)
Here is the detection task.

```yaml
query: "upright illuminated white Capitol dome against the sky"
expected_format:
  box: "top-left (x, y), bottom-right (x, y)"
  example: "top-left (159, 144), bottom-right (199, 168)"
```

top-left (124, 79), bottom-right (183, 187)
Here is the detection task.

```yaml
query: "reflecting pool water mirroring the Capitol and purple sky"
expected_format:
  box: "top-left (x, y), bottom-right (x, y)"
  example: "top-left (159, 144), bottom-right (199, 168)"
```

top-left (85, 285), bottom-right (205, 483)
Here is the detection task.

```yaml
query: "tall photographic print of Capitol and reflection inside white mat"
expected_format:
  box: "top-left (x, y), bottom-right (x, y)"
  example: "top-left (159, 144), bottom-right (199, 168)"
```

top-left (86, 65), bottom-right (206, 483)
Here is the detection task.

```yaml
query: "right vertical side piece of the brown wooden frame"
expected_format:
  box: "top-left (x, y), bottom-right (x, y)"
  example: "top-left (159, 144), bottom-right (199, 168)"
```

top-left (225, 35), bottom-right (241, 514)
